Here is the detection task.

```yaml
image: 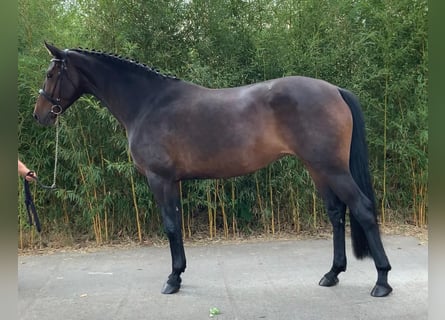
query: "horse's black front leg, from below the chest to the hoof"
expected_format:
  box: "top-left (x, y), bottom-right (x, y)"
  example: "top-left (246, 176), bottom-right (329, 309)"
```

top-left (148, 174), bottom-right (186, 294)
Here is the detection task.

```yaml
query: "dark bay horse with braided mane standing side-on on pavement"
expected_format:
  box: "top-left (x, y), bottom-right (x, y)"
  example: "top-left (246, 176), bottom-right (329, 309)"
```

top-left (34, 43), bottom-right (392, 297)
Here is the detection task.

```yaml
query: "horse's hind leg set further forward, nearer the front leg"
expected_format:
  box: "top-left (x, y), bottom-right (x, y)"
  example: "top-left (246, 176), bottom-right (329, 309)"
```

top-left (319, 187), bottom-right (346, 287)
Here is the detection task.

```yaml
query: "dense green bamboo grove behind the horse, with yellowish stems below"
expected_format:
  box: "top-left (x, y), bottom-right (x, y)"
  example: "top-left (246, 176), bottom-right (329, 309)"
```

top-left (17, 0), bottom-right (428, 247)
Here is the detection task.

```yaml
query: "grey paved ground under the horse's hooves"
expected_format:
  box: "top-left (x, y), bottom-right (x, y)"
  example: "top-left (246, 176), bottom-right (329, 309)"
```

top-left (18, 236), bottom-right (428, 320)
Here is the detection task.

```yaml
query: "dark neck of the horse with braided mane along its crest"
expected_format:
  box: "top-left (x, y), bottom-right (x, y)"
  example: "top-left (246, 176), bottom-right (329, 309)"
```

top-left (73, 54), bottom-right (172, 129)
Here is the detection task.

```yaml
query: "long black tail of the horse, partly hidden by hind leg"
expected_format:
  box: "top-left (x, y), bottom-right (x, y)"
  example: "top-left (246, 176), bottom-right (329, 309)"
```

top-left (339, 88), bottom-right (377, 259)
